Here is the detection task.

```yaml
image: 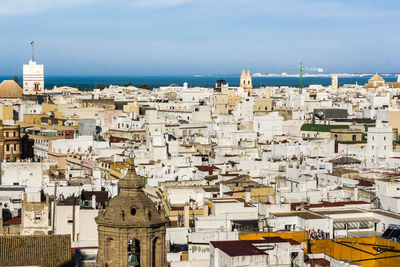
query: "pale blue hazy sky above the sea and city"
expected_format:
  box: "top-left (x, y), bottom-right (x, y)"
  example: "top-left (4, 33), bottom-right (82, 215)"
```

top-left (0, 0), bottom-right (400, 76)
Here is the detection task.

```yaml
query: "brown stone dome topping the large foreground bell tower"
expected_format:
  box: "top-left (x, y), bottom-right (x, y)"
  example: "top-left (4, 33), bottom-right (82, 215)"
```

top-left (95, 161), bottom-right (167, 228)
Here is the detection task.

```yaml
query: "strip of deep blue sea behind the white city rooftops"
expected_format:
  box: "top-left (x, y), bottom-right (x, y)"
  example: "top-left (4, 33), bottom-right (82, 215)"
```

top-left (0, 74), bottom-right (397, 90)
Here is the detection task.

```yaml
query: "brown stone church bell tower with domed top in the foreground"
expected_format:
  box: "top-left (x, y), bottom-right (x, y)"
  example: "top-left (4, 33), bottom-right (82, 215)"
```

top-left (95, 159), bottom-right (168, 267)
